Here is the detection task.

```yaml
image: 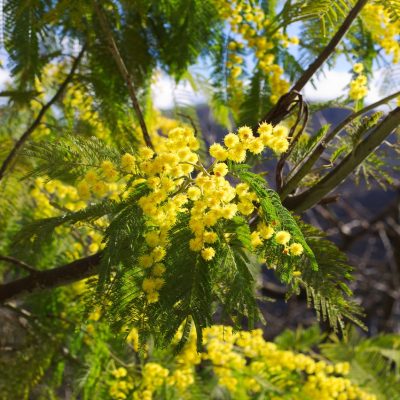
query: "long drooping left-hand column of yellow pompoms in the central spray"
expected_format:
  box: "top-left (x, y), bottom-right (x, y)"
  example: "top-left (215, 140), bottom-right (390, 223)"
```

top-left (138, 128), bottom-right (199, 303)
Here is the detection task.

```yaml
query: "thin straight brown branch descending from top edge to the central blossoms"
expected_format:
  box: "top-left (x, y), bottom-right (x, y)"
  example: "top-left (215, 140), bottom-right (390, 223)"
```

top-left (94, 1), bottom-right (154, 149)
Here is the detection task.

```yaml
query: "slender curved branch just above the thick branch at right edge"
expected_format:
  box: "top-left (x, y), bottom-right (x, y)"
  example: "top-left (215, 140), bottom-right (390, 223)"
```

top-left (280, 92), bottom-right (400, 200)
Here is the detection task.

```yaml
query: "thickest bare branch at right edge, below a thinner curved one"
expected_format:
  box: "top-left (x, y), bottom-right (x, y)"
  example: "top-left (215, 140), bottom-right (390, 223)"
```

top-left (284, 107), bottom-right (400, 212)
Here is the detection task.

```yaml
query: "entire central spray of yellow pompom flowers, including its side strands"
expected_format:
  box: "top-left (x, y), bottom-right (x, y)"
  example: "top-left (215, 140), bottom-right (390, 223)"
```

top-left (77, 123), bottom-right (303, 303)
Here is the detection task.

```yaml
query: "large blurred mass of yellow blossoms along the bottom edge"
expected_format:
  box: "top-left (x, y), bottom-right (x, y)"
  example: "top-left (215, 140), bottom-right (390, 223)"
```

top-left (202, 326), bottom-right (375, 400)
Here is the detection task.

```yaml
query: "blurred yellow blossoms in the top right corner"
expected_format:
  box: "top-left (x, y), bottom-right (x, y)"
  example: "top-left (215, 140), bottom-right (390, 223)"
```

top-left (361, 3), bottom-right (400, 64)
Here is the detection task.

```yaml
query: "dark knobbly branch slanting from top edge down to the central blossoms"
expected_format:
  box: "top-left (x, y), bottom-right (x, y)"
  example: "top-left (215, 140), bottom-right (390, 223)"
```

top-left (261, 0), bottom-right (368, 125)
